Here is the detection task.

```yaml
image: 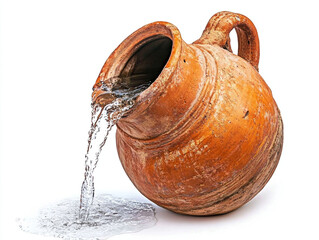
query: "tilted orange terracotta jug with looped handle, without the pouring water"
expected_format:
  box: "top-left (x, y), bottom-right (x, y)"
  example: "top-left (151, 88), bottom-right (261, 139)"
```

top-left (93, 12), bottom-right (283, 215)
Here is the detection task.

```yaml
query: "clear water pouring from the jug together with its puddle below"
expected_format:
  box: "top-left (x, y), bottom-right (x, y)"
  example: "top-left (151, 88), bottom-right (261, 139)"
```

top-left (18, 75), bottom-right (157, 239)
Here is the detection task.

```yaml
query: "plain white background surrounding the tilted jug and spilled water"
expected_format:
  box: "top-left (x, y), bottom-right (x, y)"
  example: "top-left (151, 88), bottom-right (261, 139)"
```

top-left (0, 0), bottom-right (319, 240)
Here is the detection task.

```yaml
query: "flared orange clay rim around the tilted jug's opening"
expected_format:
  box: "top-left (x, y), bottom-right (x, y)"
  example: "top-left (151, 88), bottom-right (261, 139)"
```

top-left (92, 21), bottom-right (182, 118)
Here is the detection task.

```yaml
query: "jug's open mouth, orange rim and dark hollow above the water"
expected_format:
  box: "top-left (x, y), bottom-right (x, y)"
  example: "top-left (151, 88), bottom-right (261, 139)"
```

top-left (92, 22), bottom-right (182, 117)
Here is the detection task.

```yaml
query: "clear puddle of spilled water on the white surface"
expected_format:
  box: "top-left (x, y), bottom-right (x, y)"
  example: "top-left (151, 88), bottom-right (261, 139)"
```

top-left (18, 195), bottom-right (157, 240)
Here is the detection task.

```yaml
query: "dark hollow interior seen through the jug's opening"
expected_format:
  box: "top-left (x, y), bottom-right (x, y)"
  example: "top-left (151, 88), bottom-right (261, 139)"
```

top-left (119, 35), bottom-right (172, 87)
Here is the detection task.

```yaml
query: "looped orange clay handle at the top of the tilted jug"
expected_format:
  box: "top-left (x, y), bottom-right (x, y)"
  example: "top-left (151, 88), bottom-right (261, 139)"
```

top-left (194, 11), bottom-right (259, 71)
